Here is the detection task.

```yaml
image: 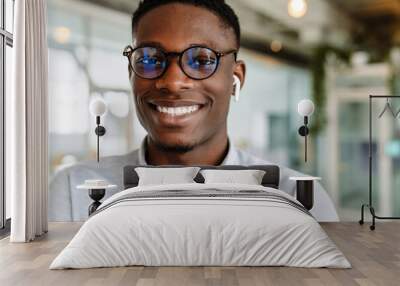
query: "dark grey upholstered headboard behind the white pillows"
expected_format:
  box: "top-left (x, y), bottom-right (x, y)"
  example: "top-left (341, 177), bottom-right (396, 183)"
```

top-left (124, 165), bottom-right (279, 189)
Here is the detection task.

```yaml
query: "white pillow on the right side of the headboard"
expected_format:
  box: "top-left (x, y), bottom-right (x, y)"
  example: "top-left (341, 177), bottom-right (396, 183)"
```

top-left (200, 169), bottom-right (265, 185)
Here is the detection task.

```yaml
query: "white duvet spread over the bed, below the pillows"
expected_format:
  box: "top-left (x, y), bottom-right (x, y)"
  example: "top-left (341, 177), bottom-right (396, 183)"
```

top-left (50, 183), bottom-right (351, 269)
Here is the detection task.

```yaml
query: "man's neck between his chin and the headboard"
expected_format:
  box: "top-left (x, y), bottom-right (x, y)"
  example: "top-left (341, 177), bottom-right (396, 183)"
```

top-left (145, 134), bottom-right (230, 166)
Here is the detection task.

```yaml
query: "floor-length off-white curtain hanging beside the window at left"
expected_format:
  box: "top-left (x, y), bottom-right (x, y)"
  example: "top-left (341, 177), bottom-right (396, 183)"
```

top-left (6, 0), bottom-right (48, 242)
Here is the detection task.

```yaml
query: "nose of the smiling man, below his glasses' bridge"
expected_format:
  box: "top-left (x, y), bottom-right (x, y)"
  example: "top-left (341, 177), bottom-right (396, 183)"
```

top-left (156, 58), bottom-right (194, 93)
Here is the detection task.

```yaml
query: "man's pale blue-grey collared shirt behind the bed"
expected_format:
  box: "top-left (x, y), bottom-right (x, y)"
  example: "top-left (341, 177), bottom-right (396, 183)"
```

top-left (49, 138), bottom-right (339, 221)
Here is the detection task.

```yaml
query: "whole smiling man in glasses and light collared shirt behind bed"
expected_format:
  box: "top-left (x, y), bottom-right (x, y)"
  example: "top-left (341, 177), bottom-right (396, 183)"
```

top-left (49, 0), bottom-right (338, 221)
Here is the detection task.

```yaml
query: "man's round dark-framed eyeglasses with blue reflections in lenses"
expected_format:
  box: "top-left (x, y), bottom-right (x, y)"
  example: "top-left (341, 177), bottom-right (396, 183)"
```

top-left (123, 46), bottom-right (237, 80)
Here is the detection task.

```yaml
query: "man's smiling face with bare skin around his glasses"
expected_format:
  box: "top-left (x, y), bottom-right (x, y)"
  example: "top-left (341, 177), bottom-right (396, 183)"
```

top-left (130, 4), bottom-right (244, 150)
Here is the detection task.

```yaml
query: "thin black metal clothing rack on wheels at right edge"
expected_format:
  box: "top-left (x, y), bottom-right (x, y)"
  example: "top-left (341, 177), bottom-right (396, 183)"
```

top-left (359, 95), bottom-right (400, 230)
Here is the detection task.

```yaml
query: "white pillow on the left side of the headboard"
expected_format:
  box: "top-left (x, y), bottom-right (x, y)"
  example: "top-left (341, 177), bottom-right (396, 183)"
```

top-left (135, 167), bottom-right (200, 186)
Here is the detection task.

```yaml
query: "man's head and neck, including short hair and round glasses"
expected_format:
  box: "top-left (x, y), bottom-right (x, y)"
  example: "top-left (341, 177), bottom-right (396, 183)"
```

top-left (126, 1), bottom-right (245, 165)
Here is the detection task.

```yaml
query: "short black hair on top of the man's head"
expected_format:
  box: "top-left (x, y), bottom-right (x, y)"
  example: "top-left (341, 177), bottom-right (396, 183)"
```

top-left (132, 0), bottom-right (240, 48)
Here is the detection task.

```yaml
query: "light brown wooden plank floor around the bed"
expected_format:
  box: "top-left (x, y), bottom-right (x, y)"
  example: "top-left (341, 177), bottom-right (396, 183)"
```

top-left (0, 222), bottom-right (400, 286)
